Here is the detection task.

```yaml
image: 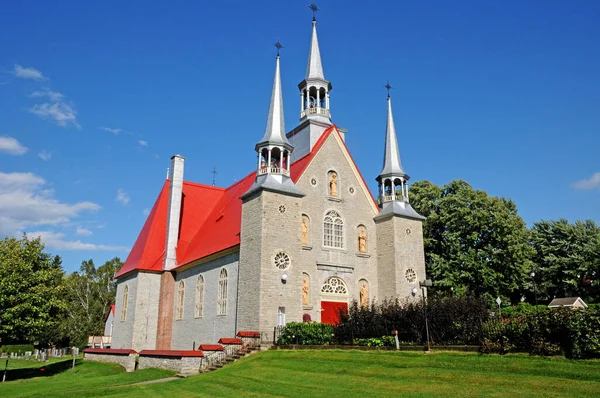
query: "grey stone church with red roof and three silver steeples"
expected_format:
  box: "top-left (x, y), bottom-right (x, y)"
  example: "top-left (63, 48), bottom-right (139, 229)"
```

top-left (112, 11), bottom-right (426, 351)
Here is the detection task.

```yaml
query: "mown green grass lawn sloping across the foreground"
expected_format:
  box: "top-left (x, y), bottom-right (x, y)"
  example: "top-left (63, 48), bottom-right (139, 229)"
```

top-left (0, 350), bottom-right (600, 398)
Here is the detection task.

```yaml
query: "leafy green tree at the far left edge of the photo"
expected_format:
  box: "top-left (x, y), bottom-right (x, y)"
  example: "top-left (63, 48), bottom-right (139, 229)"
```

top-left (0, 235), bottom-right (66, 344)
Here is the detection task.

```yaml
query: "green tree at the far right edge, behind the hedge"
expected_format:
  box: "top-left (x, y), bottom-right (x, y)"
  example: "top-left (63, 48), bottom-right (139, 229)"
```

top-left (531, 219), bottom-right (600, 302)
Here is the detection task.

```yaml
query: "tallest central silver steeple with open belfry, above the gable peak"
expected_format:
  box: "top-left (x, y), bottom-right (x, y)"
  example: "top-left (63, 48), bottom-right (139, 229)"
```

top-left (298, 2), bottom-right (332, 124)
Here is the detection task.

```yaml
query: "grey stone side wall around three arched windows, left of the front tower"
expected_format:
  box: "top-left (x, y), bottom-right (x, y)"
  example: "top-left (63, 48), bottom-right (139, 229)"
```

top-left (171, 253), bottom-right (239, 350)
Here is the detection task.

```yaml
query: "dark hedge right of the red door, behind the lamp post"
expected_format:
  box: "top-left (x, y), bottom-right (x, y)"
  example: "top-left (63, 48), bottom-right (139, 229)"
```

top-left (334, 297), bottom-right (489, 344)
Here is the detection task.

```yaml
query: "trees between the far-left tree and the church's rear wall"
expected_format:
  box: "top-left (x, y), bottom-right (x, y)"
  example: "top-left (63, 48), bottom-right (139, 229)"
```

top-left (64, 257), bottom-right (123, 346)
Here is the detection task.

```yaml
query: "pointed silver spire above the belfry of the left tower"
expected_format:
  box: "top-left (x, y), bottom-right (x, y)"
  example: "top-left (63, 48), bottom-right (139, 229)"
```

top-left (256, 45), bottom-right (292, 150)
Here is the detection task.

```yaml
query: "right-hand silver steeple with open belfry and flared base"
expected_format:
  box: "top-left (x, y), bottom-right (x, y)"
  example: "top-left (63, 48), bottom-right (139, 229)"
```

top-left (376, 86), bottom-right (424, 220)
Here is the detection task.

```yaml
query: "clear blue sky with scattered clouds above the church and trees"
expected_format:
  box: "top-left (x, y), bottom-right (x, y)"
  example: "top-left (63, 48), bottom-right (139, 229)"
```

top-left (0, 0), bottom-right (600, 271)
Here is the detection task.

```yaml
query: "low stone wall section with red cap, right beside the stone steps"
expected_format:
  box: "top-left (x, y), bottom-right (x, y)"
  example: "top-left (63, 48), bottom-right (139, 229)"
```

top-left (138, 350), bottom-right (204, 374)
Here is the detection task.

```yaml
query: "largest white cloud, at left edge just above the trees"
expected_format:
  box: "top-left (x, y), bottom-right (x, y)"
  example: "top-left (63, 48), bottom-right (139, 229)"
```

top-left (0, 172), bottom-right (100, 236)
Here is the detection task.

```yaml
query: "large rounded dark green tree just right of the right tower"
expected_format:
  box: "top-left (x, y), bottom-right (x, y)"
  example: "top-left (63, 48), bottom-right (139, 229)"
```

top-left (410, 180), bottom-right (533, 302)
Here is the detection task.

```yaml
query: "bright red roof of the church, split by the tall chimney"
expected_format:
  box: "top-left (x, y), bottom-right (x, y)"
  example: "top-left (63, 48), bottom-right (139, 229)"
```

top-left (116, 126), bottom-right (377, 277)
